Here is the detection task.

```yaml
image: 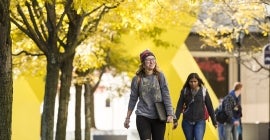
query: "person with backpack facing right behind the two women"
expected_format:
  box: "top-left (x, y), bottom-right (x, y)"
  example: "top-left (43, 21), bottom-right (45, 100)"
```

top-left (223, 82), bottom-right (243, 140)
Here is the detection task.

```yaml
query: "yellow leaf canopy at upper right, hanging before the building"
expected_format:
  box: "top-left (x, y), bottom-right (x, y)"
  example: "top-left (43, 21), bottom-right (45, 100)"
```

top-left (194, 0), bottom-right (269, 52)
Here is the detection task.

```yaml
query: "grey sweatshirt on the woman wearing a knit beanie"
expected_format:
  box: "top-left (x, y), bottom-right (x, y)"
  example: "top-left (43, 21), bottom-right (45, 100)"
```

top-left (128, 72), bottom-right (173, 119)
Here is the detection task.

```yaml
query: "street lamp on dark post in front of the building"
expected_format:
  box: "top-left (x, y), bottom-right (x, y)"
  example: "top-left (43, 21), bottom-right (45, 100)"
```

top-left (235, 29), bottom-right (245, 82)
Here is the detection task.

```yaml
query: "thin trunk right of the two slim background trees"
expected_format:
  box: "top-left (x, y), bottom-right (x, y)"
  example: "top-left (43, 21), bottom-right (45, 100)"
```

top-left (84, 83), bottom-right (91, 140)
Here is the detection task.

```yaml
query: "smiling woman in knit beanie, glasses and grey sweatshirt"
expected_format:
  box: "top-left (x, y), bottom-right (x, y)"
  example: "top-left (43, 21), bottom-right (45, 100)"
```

top-left (124, 50), bottom-right (174, 140)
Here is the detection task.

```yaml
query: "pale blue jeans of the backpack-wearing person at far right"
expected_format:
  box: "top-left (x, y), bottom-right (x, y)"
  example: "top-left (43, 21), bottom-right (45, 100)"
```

top-left (224, 123), bottom-right (239, 140)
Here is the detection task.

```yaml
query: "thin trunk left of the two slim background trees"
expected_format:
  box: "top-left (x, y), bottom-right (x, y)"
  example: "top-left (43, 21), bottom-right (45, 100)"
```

top-left (75, 84), bottom-right (82, 140)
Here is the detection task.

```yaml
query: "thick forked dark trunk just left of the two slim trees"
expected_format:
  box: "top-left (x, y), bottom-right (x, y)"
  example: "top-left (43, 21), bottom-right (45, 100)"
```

top-left (56, 6), bottom-right (84, 140)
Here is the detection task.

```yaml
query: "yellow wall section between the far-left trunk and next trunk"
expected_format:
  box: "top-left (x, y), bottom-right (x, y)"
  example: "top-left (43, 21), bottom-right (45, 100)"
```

top-left (12, 77), bottom-right (44, 140)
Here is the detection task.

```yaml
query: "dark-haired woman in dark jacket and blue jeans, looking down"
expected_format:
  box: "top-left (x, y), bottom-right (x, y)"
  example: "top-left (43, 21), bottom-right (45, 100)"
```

top-left (173, 73), bottom-right (217, 140)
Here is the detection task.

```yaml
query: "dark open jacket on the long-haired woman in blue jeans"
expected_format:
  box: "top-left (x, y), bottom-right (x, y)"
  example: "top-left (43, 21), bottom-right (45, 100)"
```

top-left (175, 87), bottom-right (217, 125)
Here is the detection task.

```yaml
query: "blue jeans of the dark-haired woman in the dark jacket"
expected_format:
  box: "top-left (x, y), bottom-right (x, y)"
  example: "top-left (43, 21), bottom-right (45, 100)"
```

top-left (182, 120), bottom-right (205, 140)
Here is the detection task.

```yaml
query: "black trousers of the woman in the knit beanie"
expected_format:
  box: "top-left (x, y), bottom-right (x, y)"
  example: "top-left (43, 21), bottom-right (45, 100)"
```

top-left (136, 115), bottom-right (166, 140)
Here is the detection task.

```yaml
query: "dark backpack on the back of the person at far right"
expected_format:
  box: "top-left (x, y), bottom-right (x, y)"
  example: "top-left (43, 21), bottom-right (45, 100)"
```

top-left (215, 98), bottom-right (228, 124)
